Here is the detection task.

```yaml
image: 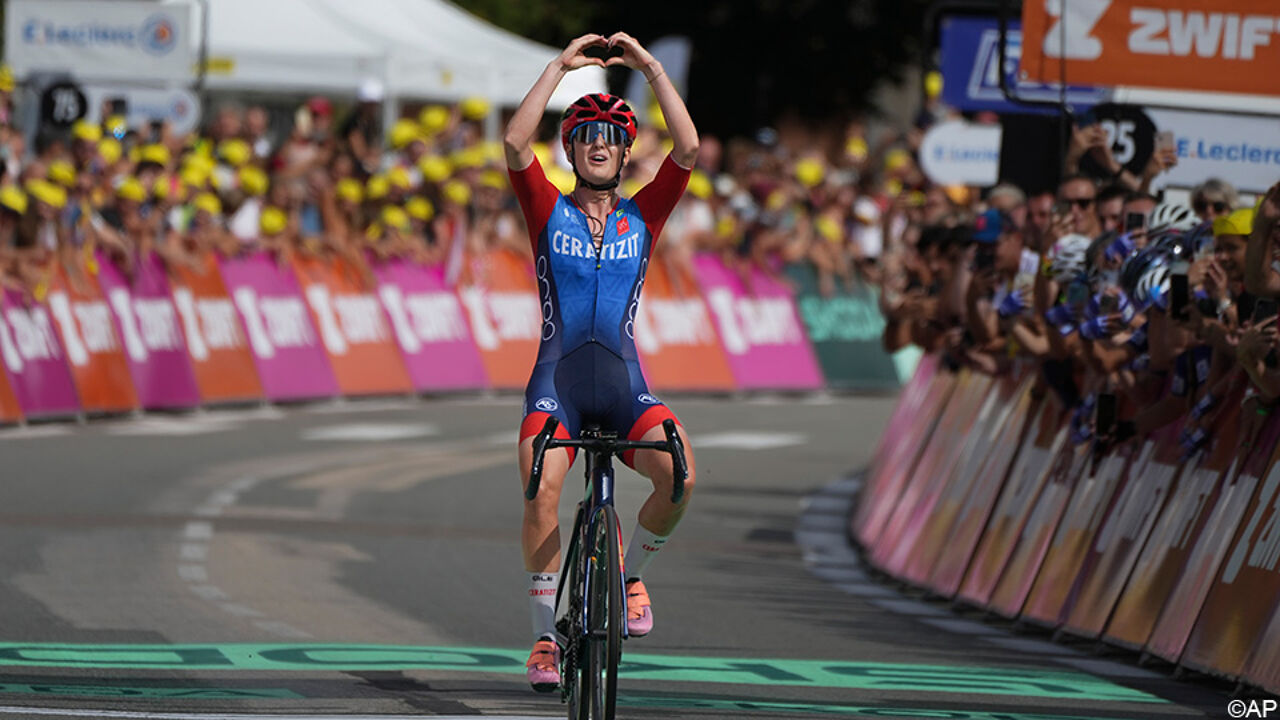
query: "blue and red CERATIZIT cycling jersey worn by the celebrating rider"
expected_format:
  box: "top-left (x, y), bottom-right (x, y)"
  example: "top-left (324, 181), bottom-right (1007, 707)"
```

top-left (509, 155), bottom-right (689, 462)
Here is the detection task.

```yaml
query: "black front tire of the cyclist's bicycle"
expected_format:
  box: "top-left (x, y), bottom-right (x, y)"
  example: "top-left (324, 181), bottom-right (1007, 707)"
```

top-left (579, 506), bottom-right (626, 720)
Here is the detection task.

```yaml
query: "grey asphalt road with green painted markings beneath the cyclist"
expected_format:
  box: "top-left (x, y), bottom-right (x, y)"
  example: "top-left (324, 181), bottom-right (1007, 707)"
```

top-left (0, 397), bottom-right (1244, 720)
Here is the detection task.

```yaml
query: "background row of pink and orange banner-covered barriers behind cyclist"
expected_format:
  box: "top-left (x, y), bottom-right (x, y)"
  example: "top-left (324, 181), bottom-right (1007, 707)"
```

top-left (0, 250), bottom-right (923, 420)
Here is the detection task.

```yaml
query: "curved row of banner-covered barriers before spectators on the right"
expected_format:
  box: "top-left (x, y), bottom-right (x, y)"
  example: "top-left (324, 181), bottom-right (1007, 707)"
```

top-left (850, 357), bottom-right (1280, 692)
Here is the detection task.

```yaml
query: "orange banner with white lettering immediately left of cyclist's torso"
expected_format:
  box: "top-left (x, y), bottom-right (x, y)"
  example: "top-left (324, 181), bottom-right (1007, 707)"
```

top-left (458, 250), bottom-right (540, 389)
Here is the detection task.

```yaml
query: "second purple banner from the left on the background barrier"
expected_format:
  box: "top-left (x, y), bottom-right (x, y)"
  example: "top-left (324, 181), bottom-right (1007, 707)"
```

top-left (97, 252), bottom-right (200, 410)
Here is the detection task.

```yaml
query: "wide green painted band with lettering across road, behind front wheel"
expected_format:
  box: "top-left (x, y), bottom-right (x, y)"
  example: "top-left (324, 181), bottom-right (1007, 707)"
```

top-left (0, 643), bottom-right (1167, 702)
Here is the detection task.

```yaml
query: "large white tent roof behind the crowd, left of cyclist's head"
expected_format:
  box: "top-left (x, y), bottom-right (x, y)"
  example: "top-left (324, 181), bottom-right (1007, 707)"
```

top-left (193, 0), bottom-right (605, 110)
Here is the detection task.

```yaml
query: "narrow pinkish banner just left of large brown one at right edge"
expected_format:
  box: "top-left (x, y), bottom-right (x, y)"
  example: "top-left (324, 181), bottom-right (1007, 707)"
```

top-left (1147, 414), bottom-right (1280, 662)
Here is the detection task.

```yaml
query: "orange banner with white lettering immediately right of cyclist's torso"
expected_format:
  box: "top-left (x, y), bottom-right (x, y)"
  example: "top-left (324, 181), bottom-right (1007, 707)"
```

top-left (636, 258), bottom-right (737, 392)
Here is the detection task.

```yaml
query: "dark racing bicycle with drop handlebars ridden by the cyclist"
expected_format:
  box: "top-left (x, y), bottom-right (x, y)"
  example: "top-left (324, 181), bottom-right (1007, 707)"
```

top-left (525, 418), bottom-right (689, 720)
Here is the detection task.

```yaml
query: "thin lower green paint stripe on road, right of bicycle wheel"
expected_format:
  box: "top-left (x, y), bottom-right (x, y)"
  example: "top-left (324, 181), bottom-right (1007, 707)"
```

top-left (618, 694), bottom-right (1152, 720)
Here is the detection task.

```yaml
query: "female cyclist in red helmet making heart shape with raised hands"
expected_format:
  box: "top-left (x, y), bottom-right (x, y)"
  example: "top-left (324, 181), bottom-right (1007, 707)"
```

top-left (504, 32), bottom-right (698, 692)
